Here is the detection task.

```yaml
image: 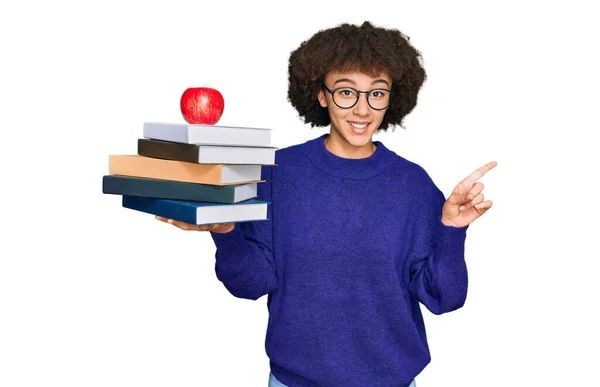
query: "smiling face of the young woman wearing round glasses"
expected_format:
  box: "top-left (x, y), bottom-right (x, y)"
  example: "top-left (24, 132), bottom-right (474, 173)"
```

top-left (318, 73), bottom-right (392, 158)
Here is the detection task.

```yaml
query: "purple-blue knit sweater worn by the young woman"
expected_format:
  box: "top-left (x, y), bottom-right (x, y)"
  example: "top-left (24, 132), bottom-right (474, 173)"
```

top-left (211, 135), bottom-right (468, 387)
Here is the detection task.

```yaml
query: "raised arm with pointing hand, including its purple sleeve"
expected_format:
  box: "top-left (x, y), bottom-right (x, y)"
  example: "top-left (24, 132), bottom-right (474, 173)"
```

top-left (409, 162), bottom-right (496, 314)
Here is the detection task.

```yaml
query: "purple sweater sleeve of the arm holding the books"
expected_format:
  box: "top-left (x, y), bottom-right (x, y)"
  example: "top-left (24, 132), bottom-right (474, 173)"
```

top-left (211, 166), bottom-right (278, 300)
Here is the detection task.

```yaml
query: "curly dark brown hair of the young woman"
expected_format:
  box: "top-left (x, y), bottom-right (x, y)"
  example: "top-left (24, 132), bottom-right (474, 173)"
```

top-left (288, 21), bottom-right (426, 131)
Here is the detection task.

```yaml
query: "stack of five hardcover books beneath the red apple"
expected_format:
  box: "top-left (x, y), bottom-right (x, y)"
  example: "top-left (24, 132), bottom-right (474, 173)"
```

top-left (102, 122), bottom-right (277, 225)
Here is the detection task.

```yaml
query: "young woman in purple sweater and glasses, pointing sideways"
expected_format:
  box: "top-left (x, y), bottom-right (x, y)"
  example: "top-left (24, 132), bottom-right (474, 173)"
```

top-left (159, 22), bottom-right (496, 387)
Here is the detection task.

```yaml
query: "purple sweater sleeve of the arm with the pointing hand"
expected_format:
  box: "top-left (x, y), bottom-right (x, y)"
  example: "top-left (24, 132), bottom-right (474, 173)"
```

top-left (409, 182), bottom-right (468, 315)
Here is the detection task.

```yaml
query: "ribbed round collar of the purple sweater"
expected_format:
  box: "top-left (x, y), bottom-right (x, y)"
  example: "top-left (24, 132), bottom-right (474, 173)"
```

top-left (305, 133), bottom-right (398, 180)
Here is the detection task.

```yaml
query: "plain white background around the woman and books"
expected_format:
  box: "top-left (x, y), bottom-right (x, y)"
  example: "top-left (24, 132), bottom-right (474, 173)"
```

top-left (0, 0), bottom-right (600, 387)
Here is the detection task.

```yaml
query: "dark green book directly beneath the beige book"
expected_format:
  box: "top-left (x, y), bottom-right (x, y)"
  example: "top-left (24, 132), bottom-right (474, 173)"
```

top-left (102, 175), bottom-right (258, 204)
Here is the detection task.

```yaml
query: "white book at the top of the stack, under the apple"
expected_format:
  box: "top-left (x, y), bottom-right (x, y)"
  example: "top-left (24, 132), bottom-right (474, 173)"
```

top-left (143, 122), bottom-right (272, 147)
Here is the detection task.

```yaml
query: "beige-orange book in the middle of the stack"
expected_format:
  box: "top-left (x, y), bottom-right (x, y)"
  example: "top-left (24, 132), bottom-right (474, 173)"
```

top-left (108, 155), bottom-right (264, 185)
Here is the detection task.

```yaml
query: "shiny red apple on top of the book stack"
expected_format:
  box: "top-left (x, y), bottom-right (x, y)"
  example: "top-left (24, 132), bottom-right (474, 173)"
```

top-left (180, 87), bottom-right (225, 125)
